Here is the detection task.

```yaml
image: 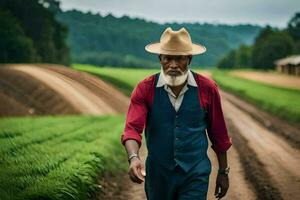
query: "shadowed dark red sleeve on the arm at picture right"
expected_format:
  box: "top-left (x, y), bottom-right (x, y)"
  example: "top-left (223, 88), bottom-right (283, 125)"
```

top-left (207, 83), bottom-right (232, 153)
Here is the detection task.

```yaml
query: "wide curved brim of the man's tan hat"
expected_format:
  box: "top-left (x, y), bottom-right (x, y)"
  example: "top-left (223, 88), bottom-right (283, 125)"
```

top-left (145, 42), bottom-right (206, 55)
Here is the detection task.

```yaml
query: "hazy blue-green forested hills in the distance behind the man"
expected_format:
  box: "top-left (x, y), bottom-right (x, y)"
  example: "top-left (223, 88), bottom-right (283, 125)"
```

top-left (56, 10), bottom-right (261, 67)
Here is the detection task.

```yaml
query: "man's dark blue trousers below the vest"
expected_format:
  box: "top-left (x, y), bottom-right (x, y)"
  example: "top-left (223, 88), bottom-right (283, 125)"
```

top-left (145, 156), bottom-right (211, 200)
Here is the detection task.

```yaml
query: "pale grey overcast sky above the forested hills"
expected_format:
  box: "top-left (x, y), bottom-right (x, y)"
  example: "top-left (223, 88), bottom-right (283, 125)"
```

top-left (60, 0), bottom-right (300, 28)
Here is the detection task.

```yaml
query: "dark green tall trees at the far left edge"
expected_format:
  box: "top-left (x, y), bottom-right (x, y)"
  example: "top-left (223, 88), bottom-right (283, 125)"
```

top-left (0, 0), bottom-right (70, 65)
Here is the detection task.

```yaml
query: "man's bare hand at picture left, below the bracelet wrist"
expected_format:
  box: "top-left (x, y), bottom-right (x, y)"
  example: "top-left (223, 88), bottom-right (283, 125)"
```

top-left (128, 157), bottom-right (146, 184)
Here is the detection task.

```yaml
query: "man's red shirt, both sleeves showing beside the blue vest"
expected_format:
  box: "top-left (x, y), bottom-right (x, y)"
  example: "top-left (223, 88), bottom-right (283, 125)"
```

top-left (121, 73), bottom-right (232, 153)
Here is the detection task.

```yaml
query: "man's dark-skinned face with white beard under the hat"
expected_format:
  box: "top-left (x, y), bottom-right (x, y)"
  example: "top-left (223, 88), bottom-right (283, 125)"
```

top-left (159, 54), bottom-right (192, 86)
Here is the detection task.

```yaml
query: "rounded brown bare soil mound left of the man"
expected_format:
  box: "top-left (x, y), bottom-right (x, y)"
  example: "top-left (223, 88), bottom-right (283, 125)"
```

top-left (0, 64), bottom-right (129, 116)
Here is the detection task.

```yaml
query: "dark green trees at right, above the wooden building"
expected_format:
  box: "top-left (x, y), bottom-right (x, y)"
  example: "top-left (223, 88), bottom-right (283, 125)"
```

top-left (218, 12), bottom-right (300, 69)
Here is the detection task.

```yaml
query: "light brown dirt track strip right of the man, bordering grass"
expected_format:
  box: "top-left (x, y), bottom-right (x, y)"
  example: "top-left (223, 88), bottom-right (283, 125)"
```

top-left (222, 93), bottom-right (300, 199)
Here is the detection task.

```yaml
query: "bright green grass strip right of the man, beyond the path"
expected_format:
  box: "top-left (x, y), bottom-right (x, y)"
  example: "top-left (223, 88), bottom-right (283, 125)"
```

top-left (212, 70), bottom-right (300, 124)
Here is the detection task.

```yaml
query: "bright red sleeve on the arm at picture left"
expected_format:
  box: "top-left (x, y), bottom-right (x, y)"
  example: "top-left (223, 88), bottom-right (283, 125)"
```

top-left (121, 83), bottom-right (148, 146)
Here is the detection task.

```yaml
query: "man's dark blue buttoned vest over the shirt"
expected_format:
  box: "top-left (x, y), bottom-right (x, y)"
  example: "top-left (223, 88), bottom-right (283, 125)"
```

top-left (145, 72), bottom-right (208, 172)
